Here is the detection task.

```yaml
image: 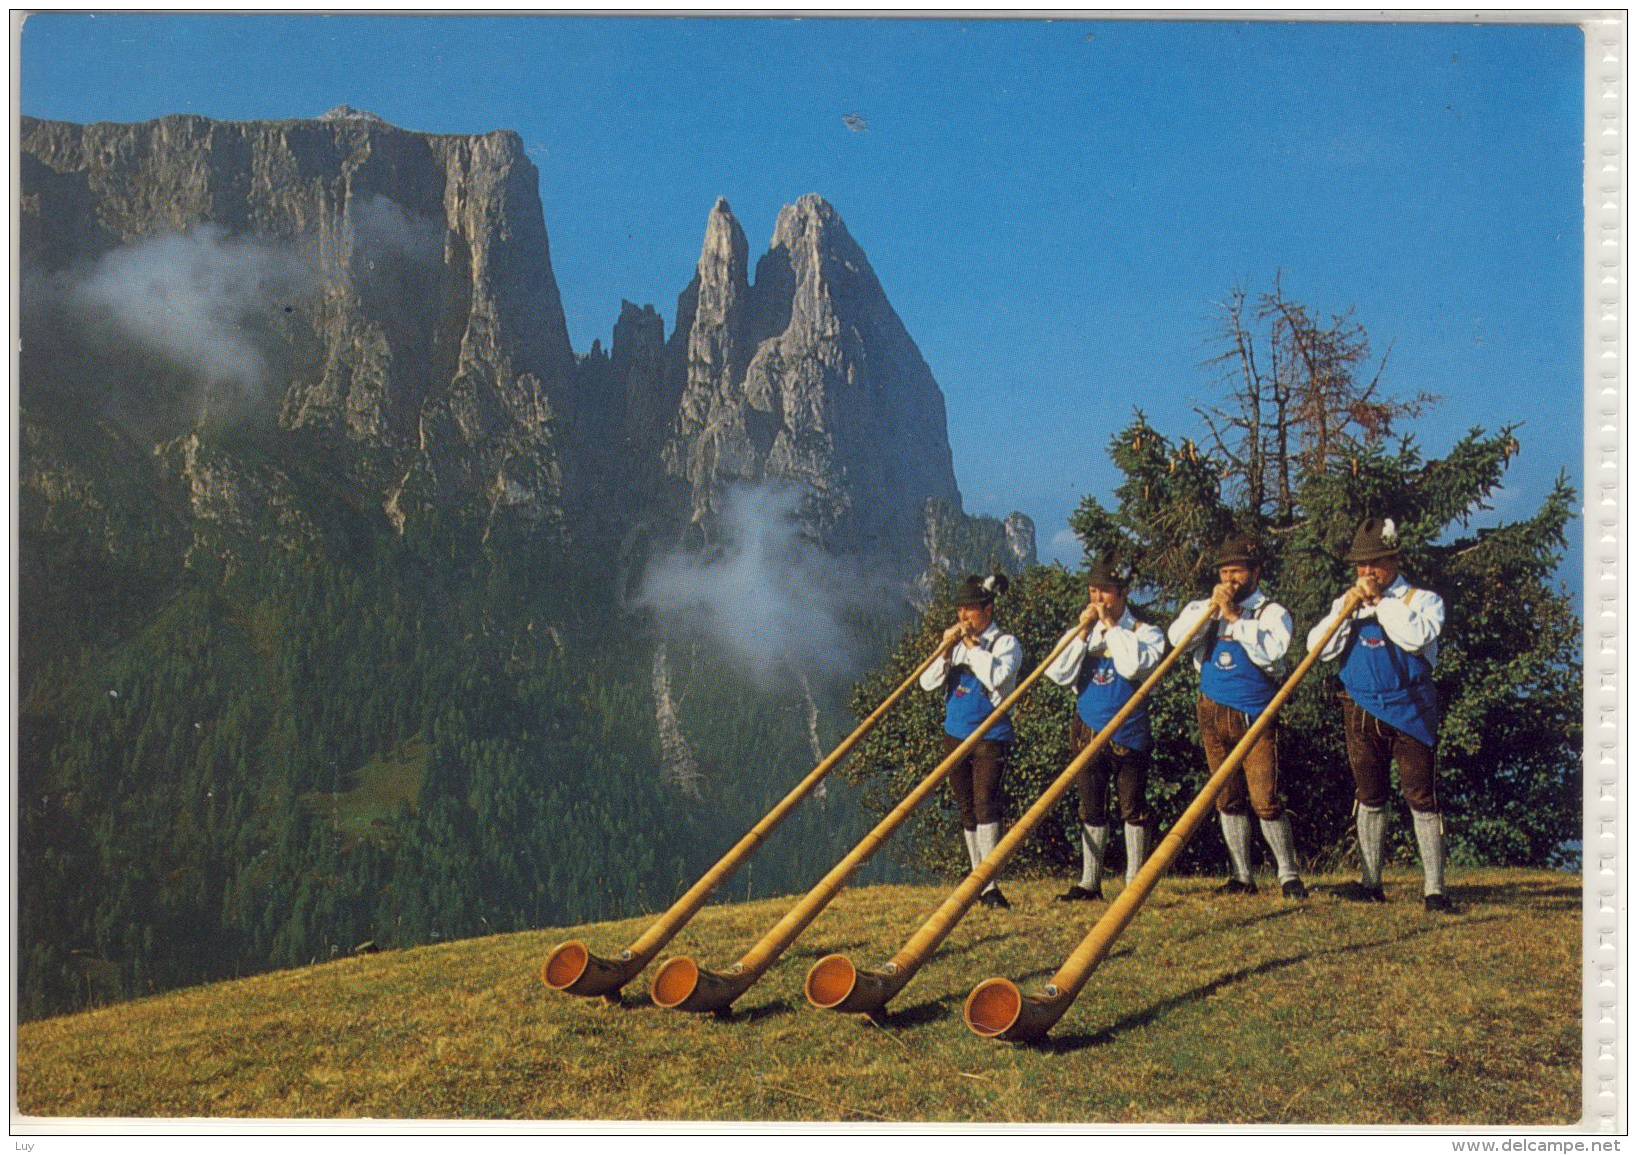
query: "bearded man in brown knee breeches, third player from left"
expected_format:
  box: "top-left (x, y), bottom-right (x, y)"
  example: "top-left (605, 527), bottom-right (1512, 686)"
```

top-left (1170, 533), bottom-right (1308, 900)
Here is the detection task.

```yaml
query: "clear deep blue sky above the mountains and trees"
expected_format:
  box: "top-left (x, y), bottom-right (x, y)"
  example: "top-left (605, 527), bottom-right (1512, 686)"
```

top-left (21, 13), bottom-right (1585, 572)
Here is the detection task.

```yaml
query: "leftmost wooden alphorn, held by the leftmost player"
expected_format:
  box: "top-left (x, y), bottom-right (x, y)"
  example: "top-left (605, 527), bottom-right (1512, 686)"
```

top-left (540, 638), bottom-right (954, 996)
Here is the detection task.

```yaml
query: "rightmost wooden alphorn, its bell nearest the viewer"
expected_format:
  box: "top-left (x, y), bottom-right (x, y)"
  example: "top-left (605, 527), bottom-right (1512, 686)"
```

top-left (961, 591), bottom-right (1360, 1042)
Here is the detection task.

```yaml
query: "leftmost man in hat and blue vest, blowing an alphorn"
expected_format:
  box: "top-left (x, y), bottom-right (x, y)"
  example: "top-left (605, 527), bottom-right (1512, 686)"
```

top-left (920, 574), bottom-right (1023, 908)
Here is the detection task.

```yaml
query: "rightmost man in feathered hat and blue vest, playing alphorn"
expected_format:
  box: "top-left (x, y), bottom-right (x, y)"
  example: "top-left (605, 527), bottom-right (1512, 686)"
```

top-left (1308, 517), bottom-right (1452, 913)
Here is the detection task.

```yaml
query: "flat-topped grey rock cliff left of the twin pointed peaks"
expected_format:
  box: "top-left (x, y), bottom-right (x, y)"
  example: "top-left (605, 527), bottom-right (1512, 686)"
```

top-left (21, 110), bottom-right (573, 525)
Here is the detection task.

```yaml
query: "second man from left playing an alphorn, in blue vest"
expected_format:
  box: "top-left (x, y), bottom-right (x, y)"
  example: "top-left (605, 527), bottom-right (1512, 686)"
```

top-left (1046, 561), bottom-right (1166, 901)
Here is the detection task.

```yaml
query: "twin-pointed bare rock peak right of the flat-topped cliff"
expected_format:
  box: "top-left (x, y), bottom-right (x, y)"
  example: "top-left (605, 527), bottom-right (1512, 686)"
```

top-left (663, 195), bottom-right (1033, 581)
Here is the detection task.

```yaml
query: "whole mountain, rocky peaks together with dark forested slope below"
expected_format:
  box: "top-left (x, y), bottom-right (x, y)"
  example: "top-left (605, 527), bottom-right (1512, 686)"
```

top-left (18, 108), bottom-right (1035, 1014)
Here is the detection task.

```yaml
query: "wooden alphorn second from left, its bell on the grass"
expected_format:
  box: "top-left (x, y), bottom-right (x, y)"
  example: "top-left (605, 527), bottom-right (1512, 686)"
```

top-left (652, 631), bottom-right (1080, 1011)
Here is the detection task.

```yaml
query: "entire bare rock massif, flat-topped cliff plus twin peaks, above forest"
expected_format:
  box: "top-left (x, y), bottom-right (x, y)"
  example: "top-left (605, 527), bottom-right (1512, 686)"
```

top-left (20, 106), bottom-right (1033, 589)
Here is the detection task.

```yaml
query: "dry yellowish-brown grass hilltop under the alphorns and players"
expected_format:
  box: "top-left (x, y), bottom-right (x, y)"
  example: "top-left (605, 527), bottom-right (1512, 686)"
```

top-left (16, 870), bottom-right (1581, 1126)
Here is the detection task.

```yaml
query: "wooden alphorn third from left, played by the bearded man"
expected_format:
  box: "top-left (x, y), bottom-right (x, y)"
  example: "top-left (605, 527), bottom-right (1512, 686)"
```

top-left (805, 607), bottom-right (1216, 1013)
